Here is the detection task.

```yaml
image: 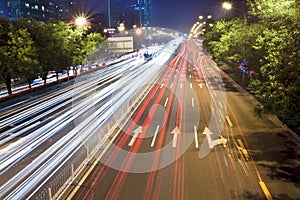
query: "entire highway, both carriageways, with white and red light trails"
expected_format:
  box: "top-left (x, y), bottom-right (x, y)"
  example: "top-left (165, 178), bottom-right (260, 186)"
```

top-left (0, 38), bottom-right (299, 199)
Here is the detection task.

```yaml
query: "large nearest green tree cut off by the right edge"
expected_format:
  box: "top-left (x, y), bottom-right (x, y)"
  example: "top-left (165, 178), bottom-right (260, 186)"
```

top-left (252, 0), bottom-right (300, 132)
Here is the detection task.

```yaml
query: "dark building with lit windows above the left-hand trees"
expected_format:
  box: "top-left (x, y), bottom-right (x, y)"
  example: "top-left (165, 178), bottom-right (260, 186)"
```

top-left (0, 0), bottom-right (82, 21)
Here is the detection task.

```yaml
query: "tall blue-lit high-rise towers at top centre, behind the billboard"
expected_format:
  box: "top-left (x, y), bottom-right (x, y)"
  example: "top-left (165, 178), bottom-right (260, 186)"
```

top-left (109, 0), bottom-right (151, 29)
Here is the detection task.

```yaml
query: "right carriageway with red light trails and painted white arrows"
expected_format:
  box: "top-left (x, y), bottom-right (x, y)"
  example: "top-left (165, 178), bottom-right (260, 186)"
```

top-left (67, 39), bottom-right (264, 199)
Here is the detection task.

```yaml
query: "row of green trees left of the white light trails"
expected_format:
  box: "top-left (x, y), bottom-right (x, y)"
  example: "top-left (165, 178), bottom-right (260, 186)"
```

top-left (0, 18), bottom-right (105, 94)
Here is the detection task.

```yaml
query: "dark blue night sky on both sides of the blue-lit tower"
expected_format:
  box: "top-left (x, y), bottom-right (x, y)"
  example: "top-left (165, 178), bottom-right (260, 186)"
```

top-left (85, 0), bottom-right (221, 33)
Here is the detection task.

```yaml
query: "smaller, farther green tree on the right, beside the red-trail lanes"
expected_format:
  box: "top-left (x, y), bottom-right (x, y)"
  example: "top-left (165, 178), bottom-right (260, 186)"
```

top-left (204, 19), bottom-right (264, 79)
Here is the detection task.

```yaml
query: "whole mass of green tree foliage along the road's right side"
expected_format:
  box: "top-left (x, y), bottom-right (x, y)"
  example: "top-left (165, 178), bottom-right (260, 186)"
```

top-left (204, 0), bottom-right (300, 132)
